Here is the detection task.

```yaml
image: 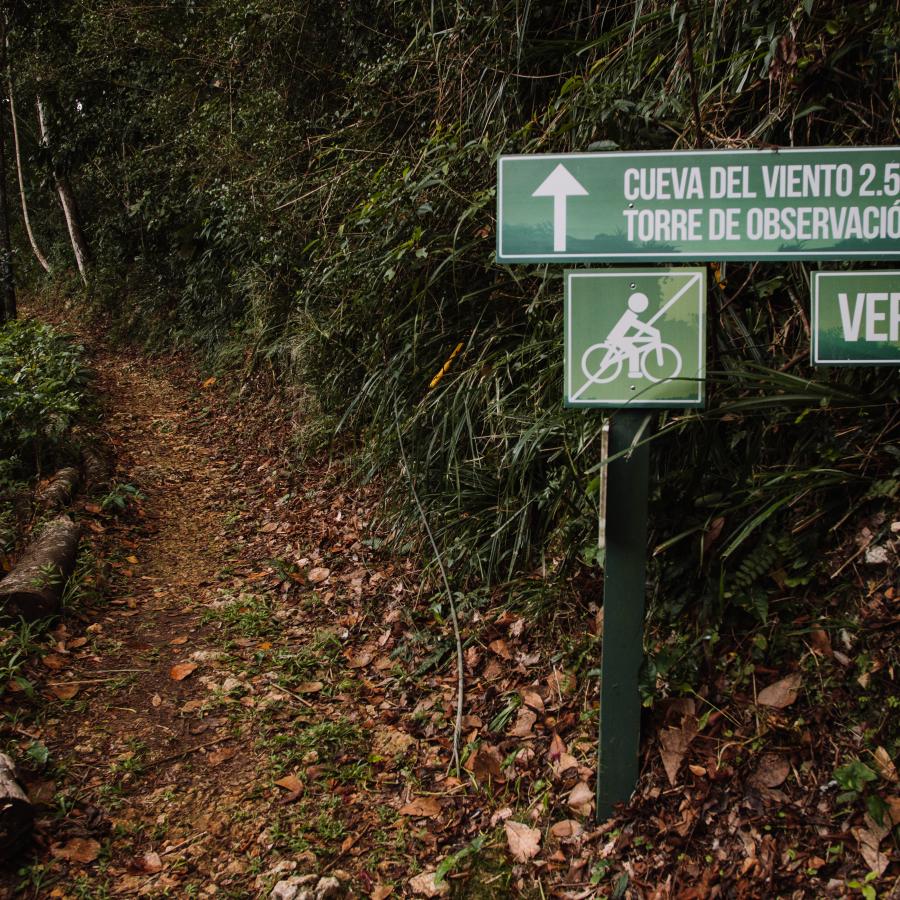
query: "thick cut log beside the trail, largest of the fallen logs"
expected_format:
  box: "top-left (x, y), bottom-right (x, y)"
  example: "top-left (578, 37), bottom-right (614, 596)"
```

top-left (0, 516), bottom-right (80, 622)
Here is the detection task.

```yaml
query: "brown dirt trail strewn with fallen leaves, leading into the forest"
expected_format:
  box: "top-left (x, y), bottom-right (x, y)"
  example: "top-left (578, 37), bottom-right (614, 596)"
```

top-left (6, 326), bottom-right (418, 897)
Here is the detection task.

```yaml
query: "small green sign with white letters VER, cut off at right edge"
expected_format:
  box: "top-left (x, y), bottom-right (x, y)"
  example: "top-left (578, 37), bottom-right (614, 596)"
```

top-left (811, 271), bottom-right (900, 366)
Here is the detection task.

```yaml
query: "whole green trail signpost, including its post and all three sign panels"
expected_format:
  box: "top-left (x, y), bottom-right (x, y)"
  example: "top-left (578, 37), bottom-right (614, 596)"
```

top-left (497, 147), bottom-right (900, 819)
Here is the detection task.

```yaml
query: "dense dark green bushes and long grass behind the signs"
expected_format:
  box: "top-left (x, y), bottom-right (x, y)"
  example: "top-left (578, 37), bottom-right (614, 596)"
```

top-left (10, 0), bottom-right (900, 675)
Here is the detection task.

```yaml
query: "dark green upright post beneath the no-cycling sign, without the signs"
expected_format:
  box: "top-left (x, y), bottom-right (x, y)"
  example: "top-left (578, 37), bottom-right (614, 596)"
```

top-left (597, 410), bottom-right (650, 821)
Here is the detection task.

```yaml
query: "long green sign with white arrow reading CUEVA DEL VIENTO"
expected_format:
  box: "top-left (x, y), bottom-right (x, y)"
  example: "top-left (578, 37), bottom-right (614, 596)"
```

top-left (497, 147), bottom-right (900, 263)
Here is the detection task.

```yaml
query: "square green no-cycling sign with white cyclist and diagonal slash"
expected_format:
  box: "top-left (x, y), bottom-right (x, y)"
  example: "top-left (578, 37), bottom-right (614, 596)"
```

top-left (564, 268), bottom-right (706, 407)
